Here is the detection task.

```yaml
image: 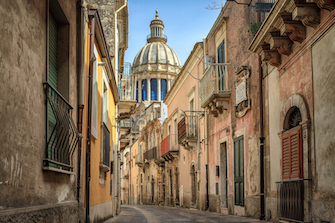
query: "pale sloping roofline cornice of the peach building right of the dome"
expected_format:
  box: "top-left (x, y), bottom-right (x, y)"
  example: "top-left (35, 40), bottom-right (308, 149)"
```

top-left (163, 42), bottom-right (202, 106)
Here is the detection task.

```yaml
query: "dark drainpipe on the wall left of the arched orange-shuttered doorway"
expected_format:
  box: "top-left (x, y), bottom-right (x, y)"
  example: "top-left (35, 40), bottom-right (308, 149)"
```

top-left (258, 56), bottom-right (265, 220)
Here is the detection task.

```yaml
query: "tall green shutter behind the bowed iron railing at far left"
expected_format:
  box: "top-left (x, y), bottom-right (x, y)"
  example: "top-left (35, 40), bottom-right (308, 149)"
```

top-left (48, 13), bottom-right (57, 160)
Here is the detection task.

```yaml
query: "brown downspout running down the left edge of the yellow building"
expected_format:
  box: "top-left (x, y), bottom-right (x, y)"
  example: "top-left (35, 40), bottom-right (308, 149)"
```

top-left (86, 10), bottom-right (95, 223)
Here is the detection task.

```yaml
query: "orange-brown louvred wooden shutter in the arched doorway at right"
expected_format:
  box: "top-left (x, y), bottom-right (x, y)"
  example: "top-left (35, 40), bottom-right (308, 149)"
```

top-left (282, 126), bottom-right (303, 179)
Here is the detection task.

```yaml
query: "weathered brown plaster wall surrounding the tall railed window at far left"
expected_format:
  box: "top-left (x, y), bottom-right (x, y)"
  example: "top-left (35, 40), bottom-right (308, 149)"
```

top-left (0, 0), bottom-right (78, 218)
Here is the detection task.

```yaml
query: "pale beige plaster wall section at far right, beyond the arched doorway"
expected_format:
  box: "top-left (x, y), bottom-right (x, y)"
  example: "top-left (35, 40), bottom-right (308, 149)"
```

top-left (311, 25), bottom-right (335, 222)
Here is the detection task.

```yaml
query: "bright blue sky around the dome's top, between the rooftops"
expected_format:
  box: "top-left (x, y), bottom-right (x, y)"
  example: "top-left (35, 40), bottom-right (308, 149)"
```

top-left (125, 0), bottom-right (224, 66)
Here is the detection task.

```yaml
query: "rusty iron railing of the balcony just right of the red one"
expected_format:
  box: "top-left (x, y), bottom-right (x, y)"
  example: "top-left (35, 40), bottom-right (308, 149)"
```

top-left (178, 116), bottom-right (198, 144)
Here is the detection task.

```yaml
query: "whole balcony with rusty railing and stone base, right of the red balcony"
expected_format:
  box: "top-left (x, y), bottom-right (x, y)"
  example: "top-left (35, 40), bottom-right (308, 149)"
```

top-left (178, 116), bottom-right (198, 149)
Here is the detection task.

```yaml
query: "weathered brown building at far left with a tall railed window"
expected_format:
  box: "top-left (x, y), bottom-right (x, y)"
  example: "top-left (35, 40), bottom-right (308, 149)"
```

top-left (0, 0), bottom-right (83, 222)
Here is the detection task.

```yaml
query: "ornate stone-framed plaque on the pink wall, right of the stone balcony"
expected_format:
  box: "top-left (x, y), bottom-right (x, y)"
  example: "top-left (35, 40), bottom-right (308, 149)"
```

top-left (235, 66), bottom-right (251, 117)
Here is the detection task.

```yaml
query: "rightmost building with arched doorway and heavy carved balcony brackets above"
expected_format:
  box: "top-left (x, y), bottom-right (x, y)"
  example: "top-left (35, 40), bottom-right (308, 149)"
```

top-left (249, 0), bottom-right (335, 222)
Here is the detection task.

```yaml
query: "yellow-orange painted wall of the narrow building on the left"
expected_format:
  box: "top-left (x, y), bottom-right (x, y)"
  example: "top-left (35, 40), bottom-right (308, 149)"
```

top-left (82, 22), bottom-right (116, 206)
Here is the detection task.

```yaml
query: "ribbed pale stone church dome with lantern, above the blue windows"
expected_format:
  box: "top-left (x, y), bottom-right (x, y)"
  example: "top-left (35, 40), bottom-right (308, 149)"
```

top-left (133, 10), bottom-right (181, 74)
